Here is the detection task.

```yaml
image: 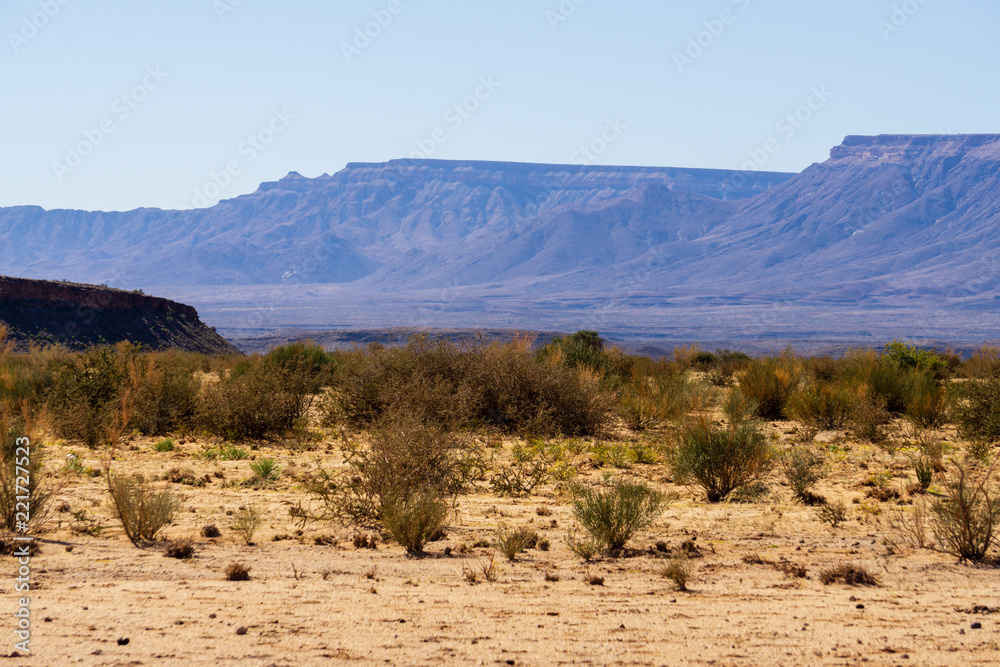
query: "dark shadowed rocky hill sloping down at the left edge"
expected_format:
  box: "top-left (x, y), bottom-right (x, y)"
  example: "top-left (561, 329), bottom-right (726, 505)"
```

top-left (0, 276), bottom-right (236, 353)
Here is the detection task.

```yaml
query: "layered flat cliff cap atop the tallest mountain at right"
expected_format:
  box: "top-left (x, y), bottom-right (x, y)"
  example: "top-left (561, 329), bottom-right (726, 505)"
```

top-left (830, 134), bottom-right (1000, 163)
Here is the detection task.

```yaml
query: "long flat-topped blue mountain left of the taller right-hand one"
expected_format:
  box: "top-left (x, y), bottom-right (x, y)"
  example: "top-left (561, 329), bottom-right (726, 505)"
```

top-left (0, 160), bottom-right (788, 289)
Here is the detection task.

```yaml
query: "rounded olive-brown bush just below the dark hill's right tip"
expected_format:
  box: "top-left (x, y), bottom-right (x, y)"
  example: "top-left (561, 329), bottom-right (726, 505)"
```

top-left (199, 357), bottom-right (305, 440)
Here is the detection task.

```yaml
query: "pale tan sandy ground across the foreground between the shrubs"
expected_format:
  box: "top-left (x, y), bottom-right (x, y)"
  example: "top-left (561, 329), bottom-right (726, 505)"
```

top-left (0, 424), bottom-right (1000, 667)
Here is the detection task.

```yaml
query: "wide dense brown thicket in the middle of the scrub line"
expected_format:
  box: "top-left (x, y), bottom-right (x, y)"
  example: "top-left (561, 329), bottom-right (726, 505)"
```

top-left (324, 337), bottom-right (610, 435)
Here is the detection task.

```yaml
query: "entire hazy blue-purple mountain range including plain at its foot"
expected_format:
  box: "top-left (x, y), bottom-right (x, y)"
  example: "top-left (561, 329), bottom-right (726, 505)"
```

top-left (0, 135), bottom-right (1000, 342)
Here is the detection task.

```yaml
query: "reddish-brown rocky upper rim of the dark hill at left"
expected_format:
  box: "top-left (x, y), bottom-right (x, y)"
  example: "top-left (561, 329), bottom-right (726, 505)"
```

top-left (0, 276), bottom-right (198, 321)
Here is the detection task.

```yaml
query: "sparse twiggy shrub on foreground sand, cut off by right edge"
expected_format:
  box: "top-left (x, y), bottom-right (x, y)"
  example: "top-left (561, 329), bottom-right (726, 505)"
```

top-left (931, 464), bottom-right (1000, 563)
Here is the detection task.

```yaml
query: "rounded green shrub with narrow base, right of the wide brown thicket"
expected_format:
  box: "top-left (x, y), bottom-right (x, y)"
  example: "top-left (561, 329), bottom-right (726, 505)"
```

top-left (670, 419), bottom-right (773, 503)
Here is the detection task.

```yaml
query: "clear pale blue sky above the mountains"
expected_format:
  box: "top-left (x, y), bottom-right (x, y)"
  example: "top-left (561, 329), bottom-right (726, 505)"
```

top-left (0, 0), bottom-right (1000, 210)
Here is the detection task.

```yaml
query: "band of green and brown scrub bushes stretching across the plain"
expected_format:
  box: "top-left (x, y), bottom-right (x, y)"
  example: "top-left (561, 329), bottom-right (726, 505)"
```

top-left (0, 324), bottom-right (1000, 560)
